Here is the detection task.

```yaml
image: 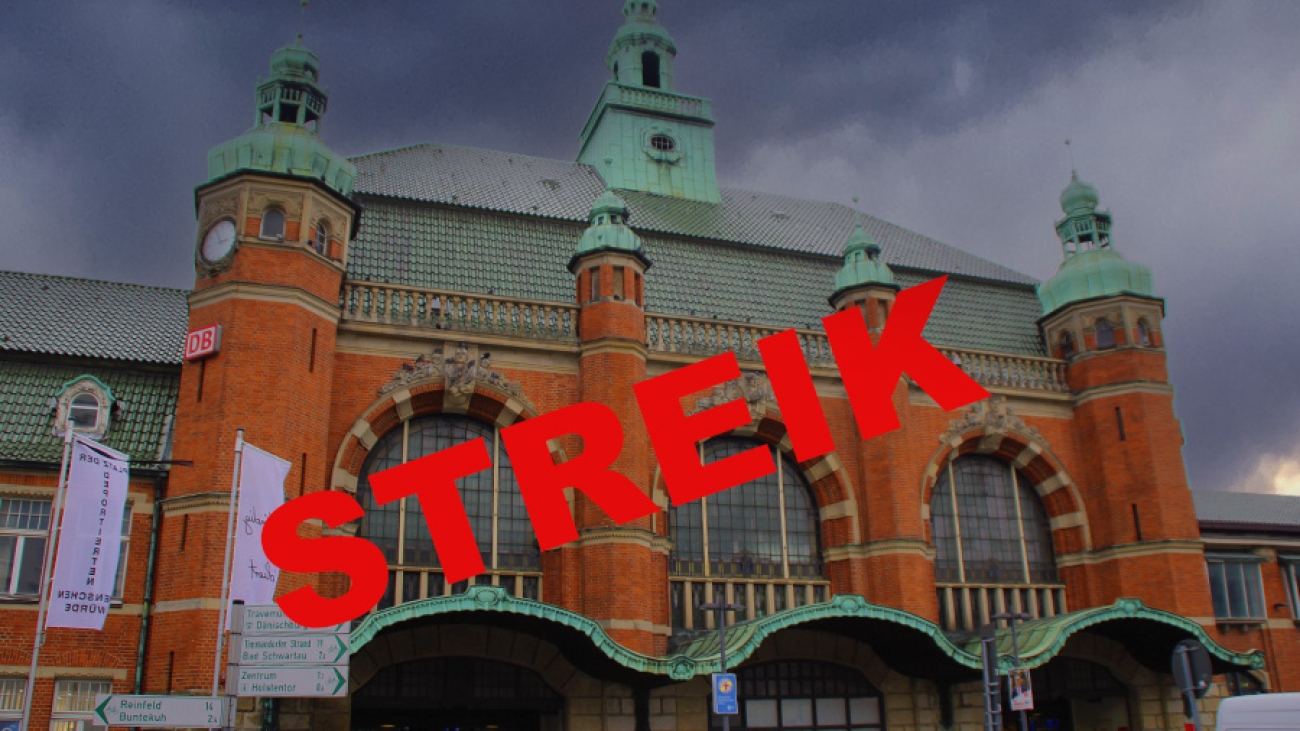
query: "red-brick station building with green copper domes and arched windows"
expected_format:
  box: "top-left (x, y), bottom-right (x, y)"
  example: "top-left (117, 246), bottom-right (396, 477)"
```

top-left (0, 0), bottom-right (1284, 731)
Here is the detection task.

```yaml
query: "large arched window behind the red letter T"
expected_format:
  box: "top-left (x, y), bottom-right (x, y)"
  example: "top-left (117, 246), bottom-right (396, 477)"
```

top-left (356, 415), bottom-right (542, 609)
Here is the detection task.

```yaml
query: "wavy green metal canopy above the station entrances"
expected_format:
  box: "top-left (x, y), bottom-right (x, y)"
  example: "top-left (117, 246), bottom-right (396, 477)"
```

top-left (352, 587), bottom-right (1264, 683)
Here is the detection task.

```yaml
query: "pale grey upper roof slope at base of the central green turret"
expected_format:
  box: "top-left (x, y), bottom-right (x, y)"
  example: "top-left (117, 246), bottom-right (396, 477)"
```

top-left (352, 143), bottom-right (1037, 286)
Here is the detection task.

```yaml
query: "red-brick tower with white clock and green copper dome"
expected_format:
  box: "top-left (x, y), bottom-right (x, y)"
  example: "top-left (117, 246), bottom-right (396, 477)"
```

top-left (147, 36), bottom-right (360, 693)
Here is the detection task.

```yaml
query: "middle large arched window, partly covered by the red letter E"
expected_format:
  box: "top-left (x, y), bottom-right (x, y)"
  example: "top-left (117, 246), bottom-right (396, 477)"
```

top-left (668, 437), bottom-right (828, 630)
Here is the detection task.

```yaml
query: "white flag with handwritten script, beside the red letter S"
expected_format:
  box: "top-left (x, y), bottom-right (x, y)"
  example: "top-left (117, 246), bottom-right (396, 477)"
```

top-left (226, 442), bottom-right (290, 619)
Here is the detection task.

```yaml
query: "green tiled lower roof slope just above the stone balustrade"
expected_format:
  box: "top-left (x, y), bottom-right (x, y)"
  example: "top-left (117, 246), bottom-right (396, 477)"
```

top-left (348, 193), bottom-right (1043, 355)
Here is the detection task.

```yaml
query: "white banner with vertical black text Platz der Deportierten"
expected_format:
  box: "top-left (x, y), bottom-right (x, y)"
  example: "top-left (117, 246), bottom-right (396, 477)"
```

top-left (46, 436), bottom-right (131, 630)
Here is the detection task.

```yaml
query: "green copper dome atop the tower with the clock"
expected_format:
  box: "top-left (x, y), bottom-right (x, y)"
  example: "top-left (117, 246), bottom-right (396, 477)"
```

top-left (208, 39), bottom-right (356, 195)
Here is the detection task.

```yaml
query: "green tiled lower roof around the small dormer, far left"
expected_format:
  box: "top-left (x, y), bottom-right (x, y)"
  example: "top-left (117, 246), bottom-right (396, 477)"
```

top-left (0, 360), bottom-right (181, 462)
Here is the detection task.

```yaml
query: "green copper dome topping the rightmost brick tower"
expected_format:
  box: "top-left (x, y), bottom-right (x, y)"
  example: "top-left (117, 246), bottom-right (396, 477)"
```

top-left (1039, 172), bottom-right (1156, 315)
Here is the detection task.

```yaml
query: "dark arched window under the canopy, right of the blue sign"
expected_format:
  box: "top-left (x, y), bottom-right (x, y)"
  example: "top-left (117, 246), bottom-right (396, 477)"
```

top-left (736, 661), bottom-right (884, 731)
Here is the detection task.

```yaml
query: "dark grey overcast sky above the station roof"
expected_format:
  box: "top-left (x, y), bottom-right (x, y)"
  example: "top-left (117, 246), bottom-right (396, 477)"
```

top-left (0, 0), bottom-right (1300, 494)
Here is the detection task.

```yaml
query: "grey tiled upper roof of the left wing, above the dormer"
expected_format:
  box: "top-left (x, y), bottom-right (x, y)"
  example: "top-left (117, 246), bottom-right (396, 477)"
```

top-left (0, 272), bottom-right (189, 364)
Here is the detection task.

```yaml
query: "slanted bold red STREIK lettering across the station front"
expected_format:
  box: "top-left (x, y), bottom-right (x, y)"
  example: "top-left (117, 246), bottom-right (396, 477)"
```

top-left (261, 277), bottom-right (989, 627)
